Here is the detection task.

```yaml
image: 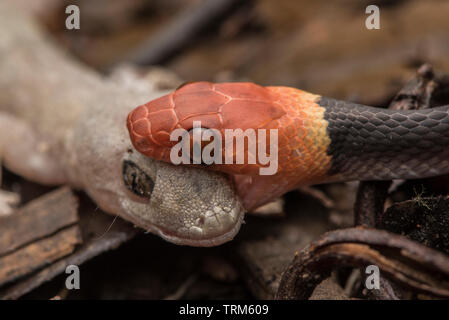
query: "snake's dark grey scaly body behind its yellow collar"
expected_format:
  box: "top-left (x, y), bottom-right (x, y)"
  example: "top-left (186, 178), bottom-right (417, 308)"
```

top-left (318, 97), bottom-right (449, 180)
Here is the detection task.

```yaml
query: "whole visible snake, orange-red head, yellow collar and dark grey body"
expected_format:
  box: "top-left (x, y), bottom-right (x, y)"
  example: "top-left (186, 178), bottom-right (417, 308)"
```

top-left (127, 82), bottom-right (449, 209)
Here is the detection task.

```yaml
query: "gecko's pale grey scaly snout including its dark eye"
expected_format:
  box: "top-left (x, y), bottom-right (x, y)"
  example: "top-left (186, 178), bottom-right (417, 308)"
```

top-left (121, 150), bottom-right (244, 246)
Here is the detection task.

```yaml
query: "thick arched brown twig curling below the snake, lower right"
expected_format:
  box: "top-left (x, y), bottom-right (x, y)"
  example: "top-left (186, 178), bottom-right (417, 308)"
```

top-left (276, 228), bottom-right (449, 299)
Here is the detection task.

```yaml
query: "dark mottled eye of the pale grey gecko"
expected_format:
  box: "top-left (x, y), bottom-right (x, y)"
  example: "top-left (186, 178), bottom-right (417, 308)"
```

top-left (123, 160), bottom-right (154, 199)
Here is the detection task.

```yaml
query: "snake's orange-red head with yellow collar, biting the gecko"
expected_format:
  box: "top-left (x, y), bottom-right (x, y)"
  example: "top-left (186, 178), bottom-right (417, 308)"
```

top-left (127, 82), bottom-right (329, 210)
